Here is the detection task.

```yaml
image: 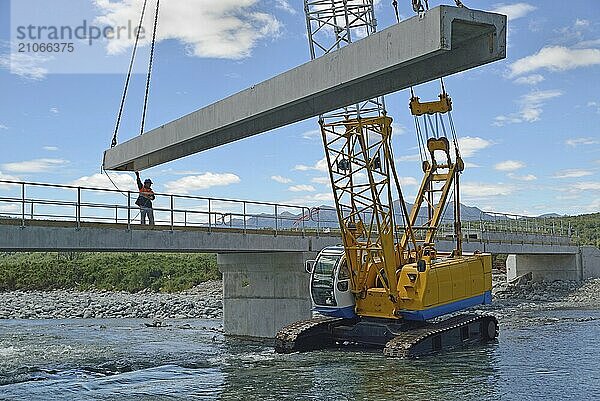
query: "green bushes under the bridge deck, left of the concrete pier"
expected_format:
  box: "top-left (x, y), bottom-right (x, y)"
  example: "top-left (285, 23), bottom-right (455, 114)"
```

top-left (0, 252), bottom-right (221, 292)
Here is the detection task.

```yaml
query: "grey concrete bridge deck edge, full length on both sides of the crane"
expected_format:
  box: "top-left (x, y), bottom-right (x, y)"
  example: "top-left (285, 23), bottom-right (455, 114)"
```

top-left (0, 220), bottom-right (579, 254)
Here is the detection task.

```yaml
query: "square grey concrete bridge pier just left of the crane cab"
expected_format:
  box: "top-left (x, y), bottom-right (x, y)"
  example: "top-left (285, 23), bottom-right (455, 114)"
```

top-left (217, 252), bottom-right (315, 338)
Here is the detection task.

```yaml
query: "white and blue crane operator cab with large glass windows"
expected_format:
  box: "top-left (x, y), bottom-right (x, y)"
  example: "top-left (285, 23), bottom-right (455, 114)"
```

top-left (306, 246), bottom-right (356, 318)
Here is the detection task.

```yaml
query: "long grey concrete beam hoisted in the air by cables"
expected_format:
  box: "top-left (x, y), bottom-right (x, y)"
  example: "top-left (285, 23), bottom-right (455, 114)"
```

top-left (104, 6), bottom-right (506, 171)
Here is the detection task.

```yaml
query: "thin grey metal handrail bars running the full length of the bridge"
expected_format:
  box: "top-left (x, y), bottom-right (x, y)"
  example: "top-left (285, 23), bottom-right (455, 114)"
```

top-left (0, 180), bottom-right (576, 242)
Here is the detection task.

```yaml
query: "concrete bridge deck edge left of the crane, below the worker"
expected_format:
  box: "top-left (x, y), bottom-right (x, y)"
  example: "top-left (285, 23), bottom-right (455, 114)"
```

top-left (0, 224), bottom-right (340, 253)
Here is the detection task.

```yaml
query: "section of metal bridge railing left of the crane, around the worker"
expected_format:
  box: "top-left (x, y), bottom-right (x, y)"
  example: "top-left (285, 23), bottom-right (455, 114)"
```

top-left (0, 180), bottom-right (310, 235)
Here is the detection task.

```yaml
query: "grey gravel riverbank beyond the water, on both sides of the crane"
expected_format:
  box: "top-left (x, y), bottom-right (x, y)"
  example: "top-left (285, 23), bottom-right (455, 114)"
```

top-left (0, 274), bottom-right (600, 319)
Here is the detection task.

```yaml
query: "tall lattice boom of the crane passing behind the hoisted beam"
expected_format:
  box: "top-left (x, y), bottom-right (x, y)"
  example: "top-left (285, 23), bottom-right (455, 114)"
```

top-left (304, 0), bottom-right (408, 298)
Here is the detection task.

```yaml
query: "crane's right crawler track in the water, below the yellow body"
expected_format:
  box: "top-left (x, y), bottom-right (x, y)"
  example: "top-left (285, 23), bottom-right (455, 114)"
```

top-left (383, 314), bottom-right (498, 358)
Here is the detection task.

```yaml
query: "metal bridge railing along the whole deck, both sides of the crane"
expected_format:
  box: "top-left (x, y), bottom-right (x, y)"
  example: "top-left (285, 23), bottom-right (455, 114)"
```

top-left (0, 180), bottom-right (576, 242)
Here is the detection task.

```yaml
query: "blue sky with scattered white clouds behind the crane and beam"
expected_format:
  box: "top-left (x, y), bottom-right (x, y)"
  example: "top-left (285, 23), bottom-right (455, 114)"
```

top-left (0, 0), bottom-right (600, 215)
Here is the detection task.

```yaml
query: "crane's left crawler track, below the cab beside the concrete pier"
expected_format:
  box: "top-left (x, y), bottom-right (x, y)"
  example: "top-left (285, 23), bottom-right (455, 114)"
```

top-left (275, 317), bottom-right (349, 354)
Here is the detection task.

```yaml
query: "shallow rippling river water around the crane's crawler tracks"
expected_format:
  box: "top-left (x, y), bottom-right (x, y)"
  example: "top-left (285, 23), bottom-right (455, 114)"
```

top-left (0, 310), bottom-right (600, 401)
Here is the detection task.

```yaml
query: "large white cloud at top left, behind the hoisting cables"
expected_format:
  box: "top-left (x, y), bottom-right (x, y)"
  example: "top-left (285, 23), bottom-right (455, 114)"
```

top-left (94, 0), bottom-right (281, 59)
